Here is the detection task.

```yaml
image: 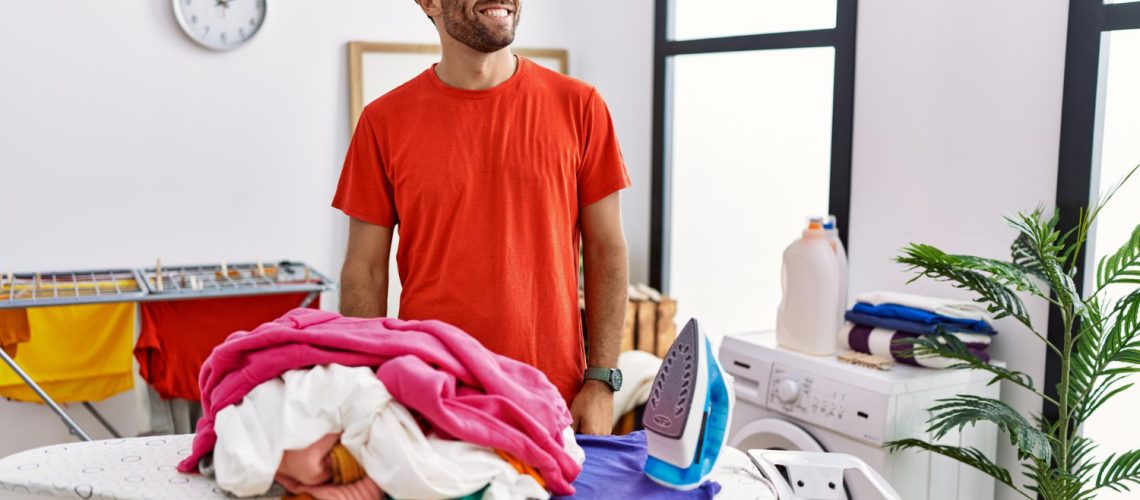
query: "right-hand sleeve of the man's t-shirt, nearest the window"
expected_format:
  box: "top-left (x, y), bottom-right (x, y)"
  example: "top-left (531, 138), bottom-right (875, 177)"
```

top-left (578, 89), bottom-right (630, 207)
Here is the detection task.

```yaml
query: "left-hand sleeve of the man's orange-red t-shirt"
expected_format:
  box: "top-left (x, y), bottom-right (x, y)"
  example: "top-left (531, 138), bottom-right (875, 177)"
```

top-left (333, 114), bottom-right (399, 228)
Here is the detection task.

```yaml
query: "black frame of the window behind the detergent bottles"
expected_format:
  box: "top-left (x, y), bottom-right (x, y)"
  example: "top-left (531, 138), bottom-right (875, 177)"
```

top-left (649, 0), bottom-right (858, 293)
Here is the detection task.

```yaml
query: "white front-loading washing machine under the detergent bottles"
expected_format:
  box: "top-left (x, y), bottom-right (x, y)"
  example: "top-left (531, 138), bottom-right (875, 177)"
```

top-left (718, 331), bottom-right (999, 500)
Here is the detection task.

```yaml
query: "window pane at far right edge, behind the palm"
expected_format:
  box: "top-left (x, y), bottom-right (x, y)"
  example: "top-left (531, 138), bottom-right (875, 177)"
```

top-left (1084, 30), bottom-right (1140, 500)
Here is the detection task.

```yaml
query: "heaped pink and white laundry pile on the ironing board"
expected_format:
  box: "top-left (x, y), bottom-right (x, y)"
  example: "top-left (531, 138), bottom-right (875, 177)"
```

top-left (178, 309), bottom-right (585, 499)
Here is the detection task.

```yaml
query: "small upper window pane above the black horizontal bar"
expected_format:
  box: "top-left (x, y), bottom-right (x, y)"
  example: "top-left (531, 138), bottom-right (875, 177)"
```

top-left (673, 0), bottom-right (836, 40)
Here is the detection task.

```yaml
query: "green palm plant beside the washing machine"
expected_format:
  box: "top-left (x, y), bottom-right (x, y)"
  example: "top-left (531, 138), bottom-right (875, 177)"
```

top-left (886, 165), bottom-right (1140, 500)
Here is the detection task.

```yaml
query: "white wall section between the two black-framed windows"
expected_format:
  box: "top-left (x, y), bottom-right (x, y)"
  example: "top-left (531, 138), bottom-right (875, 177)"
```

top-left (848, 0), bottom-right (1067, 498)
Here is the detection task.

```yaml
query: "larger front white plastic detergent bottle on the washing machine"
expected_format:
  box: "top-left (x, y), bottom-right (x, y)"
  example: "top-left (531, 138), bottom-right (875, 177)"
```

top-left (776, 219), bottom-right (839, 355)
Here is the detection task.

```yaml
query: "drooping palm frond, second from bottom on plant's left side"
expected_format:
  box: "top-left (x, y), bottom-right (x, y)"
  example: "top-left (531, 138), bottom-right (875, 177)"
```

top-left (927, 394), bottom-right (1053, 462)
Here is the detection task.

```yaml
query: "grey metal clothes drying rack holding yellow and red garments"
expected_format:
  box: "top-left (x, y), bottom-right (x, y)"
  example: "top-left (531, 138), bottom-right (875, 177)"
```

top-left (0, 261), bottom-right (336, 441)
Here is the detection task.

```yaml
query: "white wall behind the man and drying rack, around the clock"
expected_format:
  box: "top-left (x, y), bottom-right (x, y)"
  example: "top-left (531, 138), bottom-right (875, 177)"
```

top-left (0, 0), bottom-right (588, 462)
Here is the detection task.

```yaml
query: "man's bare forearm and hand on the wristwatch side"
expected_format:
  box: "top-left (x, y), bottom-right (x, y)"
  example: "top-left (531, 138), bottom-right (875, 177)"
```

top-left (570, 192), bottom-right (629, 434)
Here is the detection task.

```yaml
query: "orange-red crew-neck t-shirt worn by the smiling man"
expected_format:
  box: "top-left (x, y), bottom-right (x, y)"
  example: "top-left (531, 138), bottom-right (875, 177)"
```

top-left (333, 57), bottom-right (629, 402)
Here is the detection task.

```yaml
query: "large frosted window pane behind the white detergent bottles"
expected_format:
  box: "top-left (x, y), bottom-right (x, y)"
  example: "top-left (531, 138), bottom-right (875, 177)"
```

top-left (669, 47), bottom-right (834, 337)
